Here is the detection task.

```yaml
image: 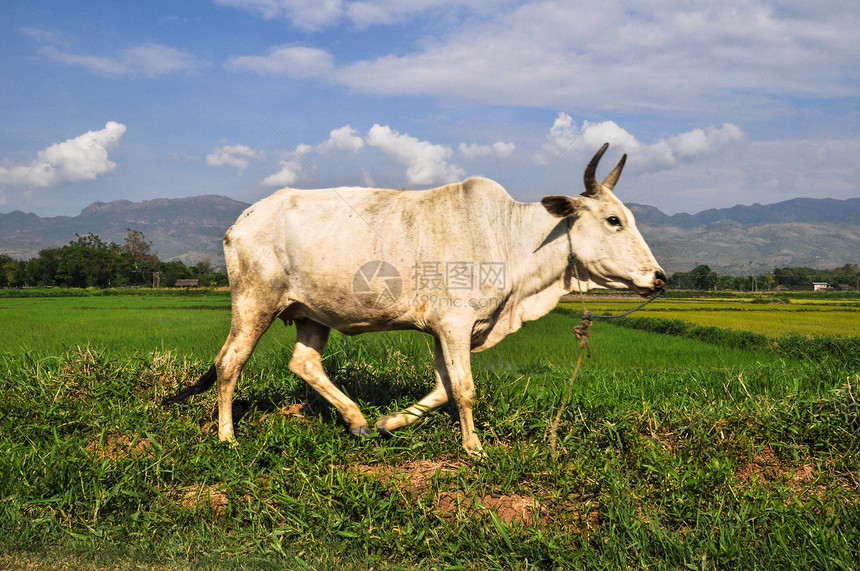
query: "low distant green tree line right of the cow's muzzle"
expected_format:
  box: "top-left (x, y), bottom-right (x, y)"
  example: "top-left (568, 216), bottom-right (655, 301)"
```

top-left (669, 264), bottom-right (860, 291)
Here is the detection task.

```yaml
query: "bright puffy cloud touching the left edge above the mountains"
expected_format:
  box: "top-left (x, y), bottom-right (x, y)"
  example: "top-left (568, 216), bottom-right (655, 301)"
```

top-left (0, 121), bottom-right (126, 188)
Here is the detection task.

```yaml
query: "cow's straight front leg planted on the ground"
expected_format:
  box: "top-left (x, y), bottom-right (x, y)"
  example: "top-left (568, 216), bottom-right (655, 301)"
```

top-left (439, 327), bottom-right (483, 454)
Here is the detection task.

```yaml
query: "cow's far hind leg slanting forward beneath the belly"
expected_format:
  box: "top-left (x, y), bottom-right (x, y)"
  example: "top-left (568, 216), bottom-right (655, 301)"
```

top-left (290, 319), bottom-right (370, 436)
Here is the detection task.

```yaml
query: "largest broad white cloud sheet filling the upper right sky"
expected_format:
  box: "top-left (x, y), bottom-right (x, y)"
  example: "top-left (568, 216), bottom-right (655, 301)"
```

top-left (336, 0), bottom-right (860, 114)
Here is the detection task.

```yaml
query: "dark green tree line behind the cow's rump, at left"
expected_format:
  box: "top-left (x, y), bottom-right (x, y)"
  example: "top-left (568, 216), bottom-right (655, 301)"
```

top-left (0, 228), bottom-right (227, 288)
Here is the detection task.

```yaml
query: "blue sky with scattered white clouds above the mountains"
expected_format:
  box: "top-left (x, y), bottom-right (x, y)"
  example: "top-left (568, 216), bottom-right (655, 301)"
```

top-left (0, 0), bottom-right (860, 216)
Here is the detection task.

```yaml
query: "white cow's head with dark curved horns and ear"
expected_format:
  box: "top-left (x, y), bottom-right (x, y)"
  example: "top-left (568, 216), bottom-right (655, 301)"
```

top-left (541, 143), bottom-right (666, 295)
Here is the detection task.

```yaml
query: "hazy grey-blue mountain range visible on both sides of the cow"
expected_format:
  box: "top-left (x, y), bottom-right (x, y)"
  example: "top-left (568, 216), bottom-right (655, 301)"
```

top-left (0, 195), bottom-right (860, 275)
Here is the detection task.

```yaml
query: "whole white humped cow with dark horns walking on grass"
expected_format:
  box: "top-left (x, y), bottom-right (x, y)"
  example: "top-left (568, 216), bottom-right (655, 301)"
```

top-left (164, 144), bottom-right (666, 453)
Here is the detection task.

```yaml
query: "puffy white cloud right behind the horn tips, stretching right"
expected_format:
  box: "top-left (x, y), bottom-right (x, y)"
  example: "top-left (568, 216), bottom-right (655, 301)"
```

top-left (535, 113), bottom-right (744, 171)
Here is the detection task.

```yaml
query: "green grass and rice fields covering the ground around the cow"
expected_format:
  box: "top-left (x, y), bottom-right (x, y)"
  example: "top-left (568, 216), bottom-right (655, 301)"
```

top-left (0, 290), bottom-right (860, 569)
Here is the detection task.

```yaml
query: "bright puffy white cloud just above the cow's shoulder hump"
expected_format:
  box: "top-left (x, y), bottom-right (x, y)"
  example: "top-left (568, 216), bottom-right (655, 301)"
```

top-left (367, 124), bottom-right (465, 186)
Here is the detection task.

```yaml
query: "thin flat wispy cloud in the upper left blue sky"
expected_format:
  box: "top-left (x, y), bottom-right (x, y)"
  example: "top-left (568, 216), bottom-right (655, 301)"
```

top-left (39, 43), bottom-right (203, 77)
